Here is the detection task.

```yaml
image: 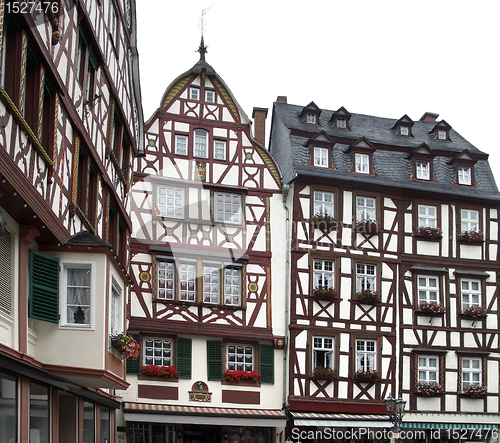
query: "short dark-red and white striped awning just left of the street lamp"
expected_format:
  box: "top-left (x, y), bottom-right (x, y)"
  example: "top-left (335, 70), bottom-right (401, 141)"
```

top-left (292, 412), bottom-right (392, 428)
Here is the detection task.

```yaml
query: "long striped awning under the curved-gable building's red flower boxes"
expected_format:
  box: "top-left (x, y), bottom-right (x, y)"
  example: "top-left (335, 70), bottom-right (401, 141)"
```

top-left (123, 402), bottom-right (286, 428)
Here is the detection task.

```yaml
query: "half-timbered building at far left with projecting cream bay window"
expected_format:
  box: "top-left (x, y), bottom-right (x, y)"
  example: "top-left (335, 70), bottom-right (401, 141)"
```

top-left (0, 0), bottom-right (143, 442)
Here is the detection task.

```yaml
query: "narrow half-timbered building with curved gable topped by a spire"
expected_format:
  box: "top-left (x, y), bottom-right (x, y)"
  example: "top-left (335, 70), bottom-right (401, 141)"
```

top-left (121, 38), bottom-right (286, 443)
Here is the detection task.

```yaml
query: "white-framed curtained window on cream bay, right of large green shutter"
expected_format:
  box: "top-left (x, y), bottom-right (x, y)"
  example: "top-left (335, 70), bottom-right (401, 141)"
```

top-left (60, 262), bottom-right (94, 327)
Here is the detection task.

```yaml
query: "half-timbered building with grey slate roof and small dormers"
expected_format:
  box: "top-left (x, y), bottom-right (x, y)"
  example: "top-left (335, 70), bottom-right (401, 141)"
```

top-left (270, 97), bottom-right (500, 440)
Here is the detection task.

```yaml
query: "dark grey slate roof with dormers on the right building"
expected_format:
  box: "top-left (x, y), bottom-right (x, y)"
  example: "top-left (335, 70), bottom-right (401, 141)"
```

top-left (270, 102), bottom-right (500, 202)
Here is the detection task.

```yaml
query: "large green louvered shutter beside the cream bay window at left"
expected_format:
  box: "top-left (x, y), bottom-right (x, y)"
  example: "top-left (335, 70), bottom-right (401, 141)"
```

top-left (28, 251), bottom-right (59, 323)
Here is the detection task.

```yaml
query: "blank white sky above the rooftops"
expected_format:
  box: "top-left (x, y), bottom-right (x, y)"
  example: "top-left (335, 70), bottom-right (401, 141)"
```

top-left (137, 0), bottom-right (500, 186)
